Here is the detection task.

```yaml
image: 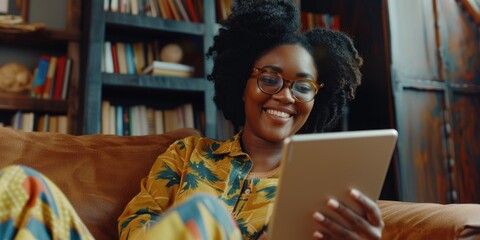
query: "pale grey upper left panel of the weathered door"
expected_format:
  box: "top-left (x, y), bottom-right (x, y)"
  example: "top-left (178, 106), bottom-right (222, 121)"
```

top-left (388, 0), bottom-right (439, 80)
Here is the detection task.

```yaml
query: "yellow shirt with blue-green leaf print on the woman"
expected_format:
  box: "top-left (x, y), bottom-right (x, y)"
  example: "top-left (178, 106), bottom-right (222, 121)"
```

top-left (118, 133), bottom-right (278, 239)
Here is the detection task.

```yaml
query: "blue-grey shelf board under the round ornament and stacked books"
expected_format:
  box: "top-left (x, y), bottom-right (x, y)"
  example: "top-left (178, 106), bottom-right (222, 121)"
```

top-left (103, 73), bottom-right (213, 91)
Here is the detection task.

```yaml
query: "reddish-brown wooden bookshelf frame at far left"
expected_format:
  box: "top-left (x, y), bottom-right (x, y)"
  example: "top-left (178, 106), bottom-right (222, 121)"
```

top-left (0, 0), bottom-right (82, 134)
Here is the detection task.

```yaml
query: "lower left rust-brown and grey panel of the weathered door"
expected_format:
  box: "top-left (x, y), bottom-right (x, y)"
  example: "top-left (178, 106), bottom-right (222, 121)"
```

top-left (395, 88), bottom-right (450, 203)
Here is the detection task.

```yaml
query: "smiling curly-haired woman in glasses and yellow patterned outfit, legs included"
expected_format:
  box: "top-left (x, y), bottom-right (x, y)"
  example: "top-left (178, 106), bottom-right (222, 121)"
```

top-left (0, 0), bottom-right (383, 239)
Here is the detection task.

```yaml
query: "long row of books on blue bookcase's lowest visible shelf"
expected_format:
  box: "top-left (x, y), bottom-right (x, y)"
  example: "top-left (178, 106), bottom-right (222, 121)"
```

top-left (102, 101), bottom-right (205, 136)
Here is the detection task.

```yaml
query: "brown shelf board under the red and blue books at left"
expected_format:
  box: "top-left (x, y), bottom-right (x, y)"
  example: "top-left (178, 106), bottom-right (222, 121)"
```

top-left (0, 92), bottom-right (68, 114)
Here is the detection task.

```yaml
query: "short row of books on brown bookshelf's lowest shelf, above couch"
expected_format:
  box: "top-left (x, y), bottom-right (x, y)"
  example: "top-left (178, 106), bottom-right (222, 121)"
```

top-left (5, 111), bottom-right (68, 133)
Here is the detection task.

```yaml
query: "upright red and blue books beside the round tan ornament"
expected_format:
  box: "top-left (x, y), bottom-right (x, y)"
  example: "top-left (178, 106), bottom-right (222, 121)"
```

top-left (30, 55), bottom-right (72, 100)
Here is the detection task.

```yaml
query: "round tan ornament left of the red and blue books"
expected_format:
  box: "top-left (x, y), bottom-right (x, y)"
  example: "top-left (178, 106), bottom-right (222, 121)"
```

top-left (0, 63), bottom-right (33, 92)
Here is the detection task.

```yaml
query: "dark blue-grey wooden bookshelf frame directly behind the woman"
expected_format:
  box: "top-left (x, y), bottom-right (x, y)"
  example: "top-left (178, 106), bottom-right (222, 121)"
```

top-left (83, 0), bottom-right (217, 137)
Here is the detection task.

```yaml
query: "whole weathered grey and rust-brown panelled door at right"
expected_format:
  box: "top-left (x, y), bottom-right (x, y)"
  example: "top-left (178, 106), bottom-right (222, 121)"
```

top-left (386, 0), bottom-right (480, 203)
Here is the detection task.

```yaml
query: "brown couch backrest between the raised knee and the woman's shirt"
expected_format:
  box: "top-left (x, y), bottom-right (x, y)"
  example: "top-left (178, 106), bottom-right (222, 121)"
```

top-left (0, 127), bottom-right (199, 239)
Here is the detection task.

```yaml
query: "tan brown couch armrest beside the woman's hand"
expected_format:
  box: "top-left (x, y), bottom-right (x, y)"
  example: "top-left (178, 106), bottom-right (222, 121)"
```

top-left (377, 200), bottom-right (480, 240)
